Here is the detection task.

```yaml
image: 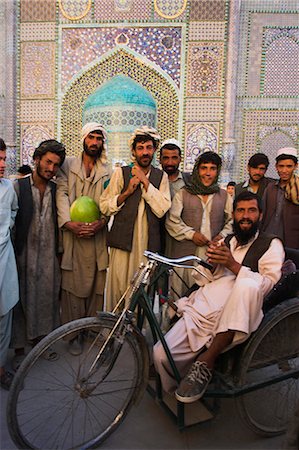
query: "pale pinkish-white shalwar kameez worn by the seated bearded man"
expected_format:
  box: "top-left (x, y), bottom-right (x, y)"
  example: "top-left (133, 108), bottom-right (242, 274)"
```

top-left (154, 238), bottom-right (284, 392)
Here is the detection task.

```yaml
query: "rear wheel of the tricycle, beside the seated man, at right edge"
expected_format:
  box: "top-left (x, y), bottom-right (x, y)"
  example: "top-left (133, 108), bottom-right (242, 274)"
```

top-left (237, 298), bottom-right (299, 436)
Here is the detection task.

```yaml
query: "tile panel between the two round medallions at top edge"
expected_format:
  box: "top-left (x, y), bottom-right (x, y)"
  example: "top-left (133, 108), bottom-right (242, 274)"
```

top-left (94, 0), bottom-right (152, 22)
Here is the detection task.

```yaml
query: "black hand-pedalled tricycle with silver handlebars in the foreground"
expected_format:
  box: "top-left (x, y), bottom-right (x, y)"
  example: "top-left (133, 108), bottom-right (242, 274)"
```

top-left (7, 252), bottom-right (299, 449)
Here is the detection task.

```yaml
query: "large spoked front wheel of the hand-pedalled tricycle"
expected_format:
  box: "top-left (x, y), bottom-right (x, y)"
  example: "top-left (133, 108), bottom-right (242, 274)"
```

top-left (7, 314), bottom-right (147, 449)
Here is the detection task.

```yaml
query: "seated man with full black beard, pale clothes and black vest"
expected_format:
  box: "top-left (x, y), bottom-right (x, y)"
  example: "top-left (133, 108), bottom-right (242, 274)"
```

top-left (154, 191), bottom-right (284, 403)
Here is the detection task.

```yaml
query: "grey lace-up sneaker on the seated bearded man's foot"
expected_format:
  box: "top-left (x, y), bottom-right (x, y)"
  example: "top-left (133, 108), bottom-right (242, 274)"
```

top-left (175, 361), bottom-right (212, 403)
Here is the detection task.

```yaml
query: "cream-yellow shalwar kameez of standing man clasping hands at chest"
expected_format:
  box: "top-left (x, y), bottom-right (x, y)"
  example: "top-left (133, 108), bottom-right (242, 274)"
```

top-left (100, 167), bottom-right (171, 311)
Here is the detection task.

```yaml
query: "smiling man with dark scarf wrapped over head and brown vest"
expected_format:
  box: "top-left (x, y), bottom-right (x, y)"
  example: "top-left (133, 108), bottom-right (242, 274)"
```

top-left (166, 151), bottom-right (232, 297)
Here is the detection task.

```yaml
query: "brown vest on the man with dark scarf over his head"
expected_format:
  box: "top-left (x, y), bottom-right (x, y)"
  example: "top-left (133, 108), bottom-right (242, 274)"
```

top-left (172, 188), bottom-right (227, 258)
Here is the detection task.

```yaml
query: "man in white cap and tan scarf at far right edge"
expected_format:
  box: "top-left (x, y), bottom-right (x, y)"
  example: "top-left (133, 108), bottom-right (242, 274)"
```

top-left (262, 147), bottom-right (299, 249)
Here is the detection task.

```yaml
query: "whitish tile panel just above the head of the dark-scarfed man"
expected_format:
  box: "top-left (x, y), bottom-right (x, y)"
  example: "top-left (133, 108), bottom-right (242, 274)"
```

top-left (184, 123), bottom-right (219, 172)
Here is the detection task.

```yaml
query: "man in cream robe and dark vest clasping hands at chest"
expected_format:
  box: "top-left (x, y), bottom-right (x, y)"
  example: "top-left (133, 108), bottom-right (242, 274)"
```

top-left (100, 126), bottom-right (171, 311)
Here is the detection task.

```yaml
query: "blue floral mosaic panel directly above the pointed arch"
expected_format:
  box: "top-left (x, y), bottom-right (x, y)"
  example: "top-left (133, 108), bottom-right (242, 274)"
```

top-left (61, 27), bottom-right (182, 89)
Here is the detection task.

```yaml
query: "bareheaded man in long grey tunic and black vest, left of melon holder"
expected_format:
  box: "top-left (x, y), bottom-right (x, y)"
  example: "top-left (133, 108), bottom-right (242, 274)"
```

top-left (11, 139), bottom-right (65, 369)
